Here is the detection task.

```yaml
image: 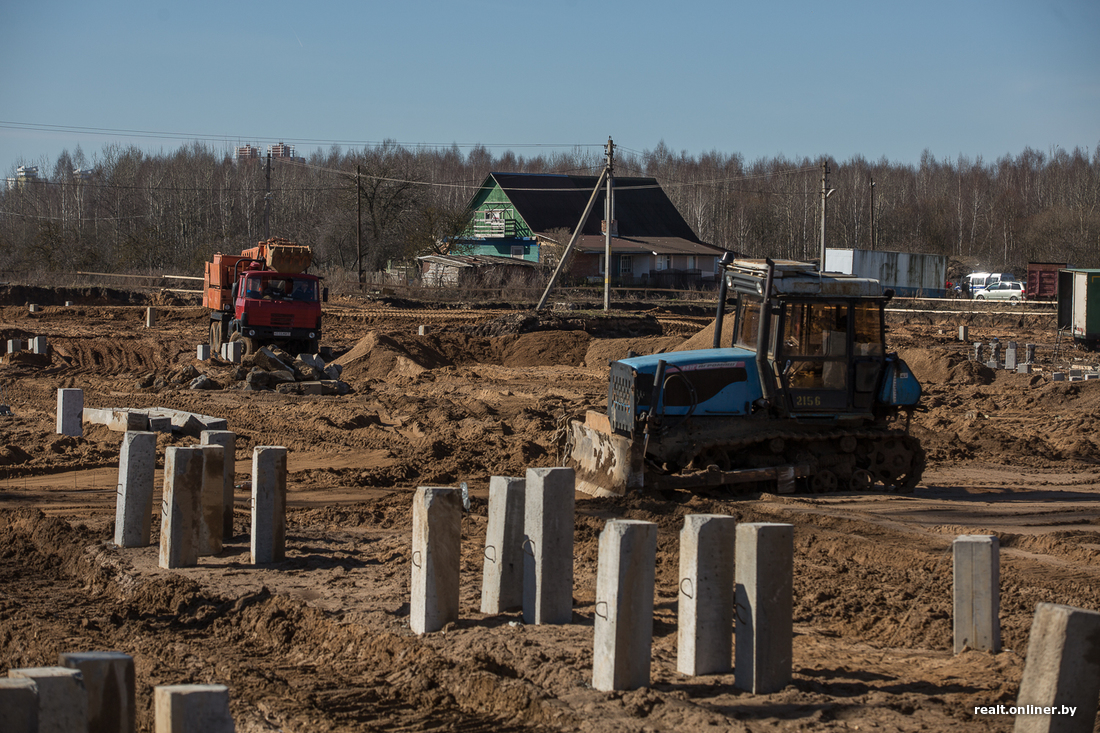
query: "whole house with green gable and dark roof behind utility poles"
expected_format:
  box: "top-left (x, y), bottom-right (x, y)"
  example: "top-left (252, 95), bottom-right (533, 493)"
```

top-left (452, 173), bottom-right (725, 287)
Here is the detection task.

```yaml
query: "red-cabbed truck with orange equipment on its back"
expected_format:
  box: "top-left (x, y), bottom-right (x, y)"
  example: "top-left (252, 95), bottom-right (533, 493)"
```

top-left (202, 238), bottom-right (328, 354)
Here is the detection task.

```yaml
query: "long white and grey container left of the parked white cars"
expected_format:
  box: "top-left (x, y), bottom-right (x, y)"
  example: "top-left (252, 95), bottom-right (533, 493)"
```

top-left (825, 249), bottom-right (947, 298)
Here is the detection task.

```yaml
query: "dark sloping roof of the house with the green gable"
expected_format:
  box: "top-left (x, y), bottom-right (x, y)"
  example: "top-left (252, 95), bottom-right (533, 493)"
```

top-left (490, 173), bottom-right (700, 242)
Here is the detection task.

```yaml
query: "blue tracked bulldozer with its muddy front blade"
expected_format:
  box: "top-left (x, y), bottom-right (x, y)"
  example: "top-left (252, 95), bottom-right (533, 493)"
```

top-left (565, 255), bottom-right (925, 496)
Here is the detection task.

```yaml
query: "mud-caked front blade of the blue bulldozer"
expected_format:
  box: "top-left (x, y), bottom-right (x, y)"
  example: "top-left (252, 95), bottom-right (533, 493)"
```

top-left (567, 412), bottom-right (645, 496)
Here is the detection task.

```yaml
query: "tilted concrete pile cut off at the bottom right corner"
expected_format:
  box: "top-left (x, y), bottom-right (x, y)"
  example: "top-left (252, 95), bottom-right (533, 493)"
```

top-left (1015, 603), bottom-right (1100, 733)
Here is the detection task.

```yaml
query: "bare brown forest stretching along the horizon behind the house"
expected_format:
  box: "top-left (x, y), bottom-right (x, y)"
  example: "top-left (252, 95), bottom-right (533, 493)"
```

top-left (0, 142), bottom-right (1100, 279)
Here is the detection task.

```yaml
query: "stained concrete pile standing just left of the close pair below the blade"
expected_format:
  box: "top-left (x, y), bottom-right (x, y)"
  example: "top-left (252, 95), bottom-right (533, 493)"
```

top-left (409, 486), bottom-right (462, 634)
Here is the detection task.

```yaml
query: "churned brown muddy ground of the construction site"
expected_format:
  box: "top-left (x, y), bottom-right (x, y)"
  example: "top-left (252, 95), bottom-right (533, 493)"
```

top-left (0, 291), bottom-right (1100, 732)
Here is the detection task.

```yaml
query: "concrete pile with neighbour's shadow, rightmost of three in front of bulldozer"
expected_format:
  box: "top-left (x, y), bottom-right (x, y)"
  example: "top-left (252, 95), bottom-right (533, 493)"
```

top-left (734, 523), bottom-right (794, 694)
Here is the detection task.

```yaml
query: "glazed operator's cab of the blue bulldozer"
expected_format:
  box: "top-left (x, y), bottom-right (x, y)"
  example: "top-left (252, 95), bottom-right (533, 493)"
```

top-left (735, 259), bottom-right (886, 417)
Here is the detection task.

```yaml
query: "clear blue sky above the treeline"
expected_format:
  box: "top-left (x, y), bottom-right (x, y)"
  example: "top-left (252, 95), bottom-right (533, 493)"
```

top-left (0, 0), bottom-right (1100, 175)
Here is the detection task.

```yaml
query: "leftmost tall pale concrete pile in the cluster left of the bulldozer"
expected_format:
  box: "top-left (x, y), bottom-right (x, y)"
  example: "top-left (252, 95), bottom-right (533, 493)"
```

top-left (114, 431), bottom-right (156, 547)
